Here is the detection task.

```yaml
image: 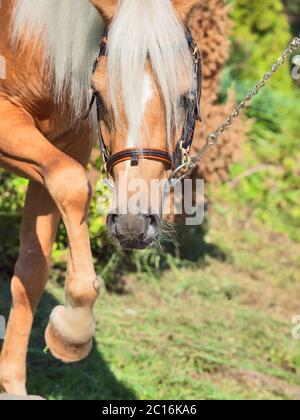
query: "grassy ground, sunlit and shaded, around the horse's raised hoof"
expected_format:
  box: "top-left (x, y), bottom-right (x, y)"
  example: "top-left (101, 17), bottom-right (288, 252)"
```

top-left (0, 206), bottom-right (300, 400)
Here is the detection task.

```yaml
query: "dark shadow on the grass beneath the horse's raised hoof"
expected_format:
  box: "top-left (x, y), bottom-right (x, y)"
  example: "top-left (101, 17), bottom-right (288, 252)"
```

top-left (0, 280), bottom-right (137, 400)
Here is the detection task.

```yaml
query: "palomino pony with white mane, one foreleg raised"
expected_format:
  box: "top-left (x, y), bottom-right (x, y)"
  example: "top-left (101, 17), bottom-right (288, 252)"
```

top-left (0, 0), bottom-right (202, 395)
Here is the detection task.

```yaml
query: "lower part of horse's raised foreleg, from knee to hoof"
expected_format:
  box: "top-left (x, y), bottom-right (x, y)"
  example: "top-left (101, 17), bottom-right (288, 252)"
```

top-left (45, 127), bottom-right (99, 363)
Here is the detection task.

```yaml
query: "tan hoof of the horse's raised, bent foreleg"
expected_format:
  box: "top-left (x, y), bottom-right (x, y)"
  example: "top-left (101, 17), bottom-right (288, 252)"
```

top-left (45, 321), bottom-right (93, 363)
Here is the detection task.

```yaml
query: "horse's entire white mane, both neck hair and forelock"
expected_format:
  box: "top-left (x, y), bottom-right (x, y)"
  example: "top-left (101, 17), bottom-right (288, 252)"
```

top-left (12, 0), bottom-right (193, 141)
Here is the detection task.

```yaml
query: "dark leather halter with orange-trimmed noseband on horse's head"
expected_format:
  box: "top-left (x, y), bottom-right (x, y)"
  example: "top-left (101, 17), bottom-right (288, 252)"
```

top-left (86, 27), bottom-right (202, 173)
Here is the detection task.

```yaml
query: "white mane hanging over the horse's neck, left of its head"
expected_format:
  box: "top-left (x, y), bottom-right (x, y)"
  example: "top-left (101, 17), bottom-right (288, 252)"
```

top-left (12, 0), bottom-right (104, 117)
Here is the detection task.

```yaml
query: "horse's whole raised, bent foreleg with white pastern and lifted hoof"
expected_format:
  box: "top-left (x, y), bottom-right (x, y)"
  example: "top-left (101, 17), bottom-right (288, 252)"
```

top-left (0, 103), bottom-right (99, 362)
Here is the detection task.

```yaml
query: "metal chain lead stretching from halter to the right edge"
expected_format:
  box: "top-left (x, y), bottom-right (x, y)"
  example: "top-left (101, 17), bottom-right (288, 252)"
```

top-left (169, 37), bottom-right (300, 186)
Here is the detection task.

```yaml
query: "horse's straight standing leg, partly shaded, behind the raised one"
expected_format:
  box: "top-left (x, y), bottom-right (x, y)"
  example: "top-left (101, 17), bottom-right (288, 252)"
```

top-left (0, 182), bottom-right (60, 396)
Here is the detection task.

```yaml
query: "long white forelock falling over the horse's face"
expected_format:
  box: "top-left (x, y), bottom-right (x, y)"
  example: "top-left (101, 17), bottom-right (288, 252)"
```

top-left (108, 0), bottom-right (193, 141)
